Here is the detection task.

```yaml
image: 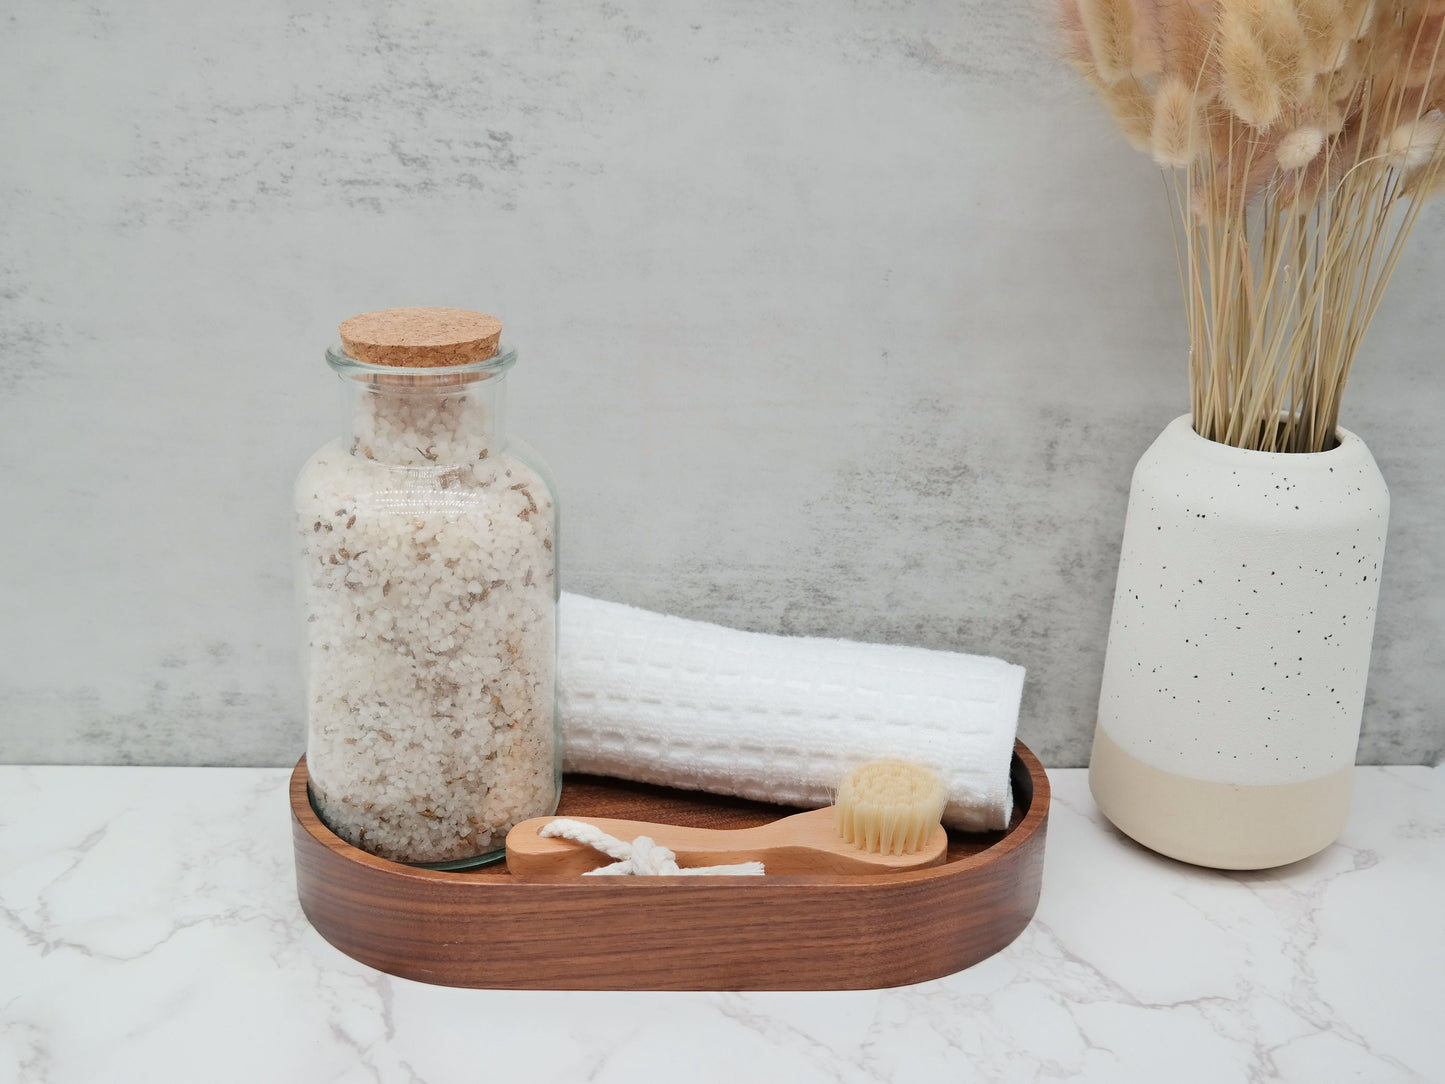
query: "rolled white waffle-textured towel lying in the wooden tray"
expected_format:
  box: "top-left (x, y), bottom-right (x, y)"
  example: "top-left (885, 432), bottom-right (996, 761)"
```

top-left (558, 594), bottom-right (1025, 831)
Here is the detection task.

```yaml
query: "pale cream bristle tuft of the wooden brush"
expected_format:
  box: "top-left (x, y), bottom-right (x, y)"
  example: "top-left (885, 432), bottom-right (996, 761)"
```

top-left (834, 760), bottom-right (948, 854)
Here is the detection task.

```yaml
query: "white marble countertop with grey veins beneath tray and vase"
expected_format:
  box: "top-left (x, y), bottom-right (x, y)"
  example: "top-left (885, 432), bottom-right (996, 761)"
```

top-left (0, 767), bottom-right (1445, 1084)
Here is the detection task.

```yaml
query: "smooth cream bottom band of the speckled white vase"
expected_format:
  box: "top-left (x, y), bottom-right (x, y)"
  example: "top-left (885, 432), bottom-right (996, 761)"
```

top-left (1090, 727), bottom-right (1354, 870)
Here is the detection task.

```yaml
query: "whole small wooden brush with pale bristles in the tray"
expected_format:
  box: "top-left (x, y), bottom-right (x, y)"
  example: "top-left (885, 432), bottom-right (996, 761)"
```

top-left (507, 760), bottom-right (948, 882)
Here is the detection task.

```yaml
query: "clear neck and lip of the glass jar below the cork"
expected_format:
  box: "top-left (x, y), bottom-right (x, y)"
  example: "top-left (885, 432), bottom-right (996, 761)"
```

top-left (327, 351), bottom-right (516, 468)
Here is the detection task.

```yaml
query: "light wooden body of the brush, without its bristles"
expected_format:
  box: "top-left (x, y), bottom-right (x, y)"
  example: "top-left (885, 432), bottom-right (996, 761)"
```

top-left (507, 806), bottom-right (948, 880)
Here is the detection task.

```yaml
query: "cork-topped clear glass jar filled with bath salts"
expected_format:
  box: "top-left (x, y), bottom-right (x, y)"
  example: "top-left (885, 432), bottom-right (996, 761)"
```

top-left (295, 309), bottom-right (561, 869)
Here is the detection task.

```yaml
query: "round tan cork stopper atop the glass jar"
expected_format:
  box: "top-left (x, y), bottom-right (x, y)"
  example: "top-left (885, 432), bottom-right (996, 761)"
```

top-left (341, 308), bottom-right (501, 369)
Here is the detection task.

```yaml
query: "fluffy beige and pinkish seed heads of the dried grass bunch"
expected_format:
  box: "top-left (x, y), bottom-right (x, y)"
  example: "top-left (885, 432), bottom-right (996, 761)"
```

top-left (1056, 0), bottom-right (1445, 185)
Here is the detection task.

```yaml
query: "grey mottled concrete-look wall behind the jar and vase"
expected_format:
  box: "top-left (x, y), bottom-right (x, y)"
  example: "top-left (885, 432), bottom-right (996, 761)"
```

top-left (0, 0), bottom-right (1445, 766)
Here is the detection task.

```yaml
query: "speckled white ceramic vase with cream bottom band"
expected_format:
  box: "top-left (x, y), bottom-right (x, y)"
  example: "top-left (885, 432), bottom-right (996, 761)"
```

top-left (1090, 415), bottom-right (1390, 869)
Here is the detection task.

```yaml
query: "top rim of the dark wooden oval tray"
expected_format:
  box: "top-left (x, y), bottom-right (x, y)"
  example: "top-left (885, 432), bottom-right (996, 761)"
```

top-left (289, 739), bottom-right (1052, 892)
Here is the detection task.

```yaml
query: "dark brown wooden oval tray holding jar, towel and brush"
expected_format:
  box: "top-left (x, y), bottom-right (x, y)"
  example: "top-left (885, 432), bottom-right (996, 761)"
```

top-left (290, 741), bottom-right (1049, 990)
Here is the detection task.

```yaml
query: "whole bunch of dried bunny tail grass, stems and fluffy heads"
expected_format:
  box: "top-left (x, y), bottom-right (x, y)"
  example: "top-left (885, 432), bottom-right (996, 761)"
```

top-left (1059, 0), bottom-right (1445, 451)
